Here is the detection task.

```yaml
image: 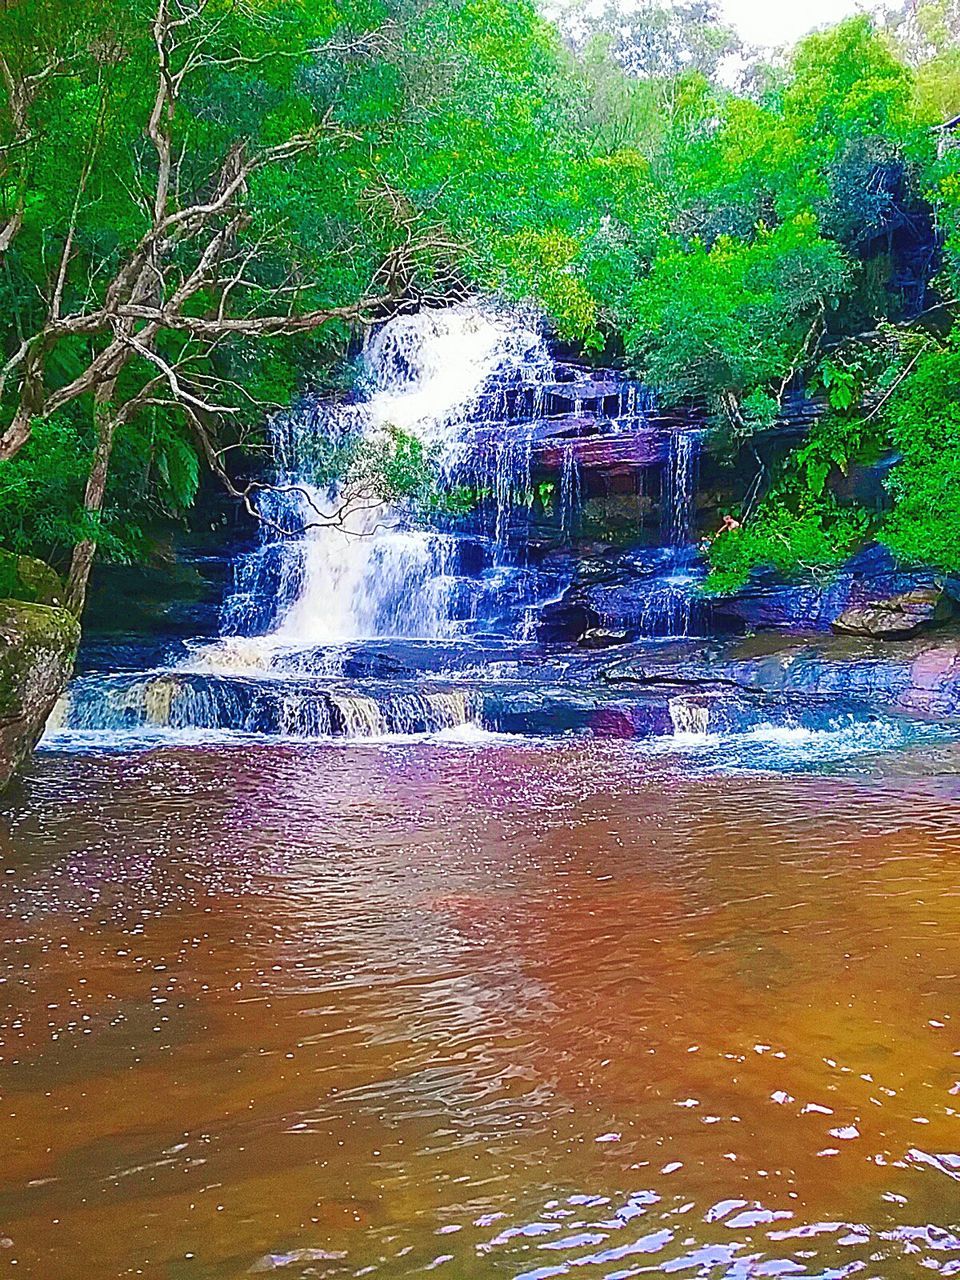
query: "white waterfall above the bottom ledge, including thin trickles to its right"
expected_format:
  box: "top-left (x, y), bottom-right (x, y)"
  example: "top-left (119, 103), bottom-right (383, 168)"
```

top-left (219, 301), bottom-right (670, 669)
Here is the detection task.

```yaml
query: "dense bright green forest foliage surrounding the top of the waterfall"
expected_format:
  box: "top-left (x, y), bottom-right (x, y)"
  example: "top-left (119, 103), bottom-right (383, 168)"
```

top-left (0, 0), bottom-right (960, 606)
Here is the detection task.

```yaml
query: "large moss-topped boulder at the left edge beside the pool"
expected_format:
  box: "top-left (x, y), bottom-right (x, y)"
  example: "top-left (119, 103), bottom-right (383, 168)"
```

top-left (0, 599), bottom-right (79, 790)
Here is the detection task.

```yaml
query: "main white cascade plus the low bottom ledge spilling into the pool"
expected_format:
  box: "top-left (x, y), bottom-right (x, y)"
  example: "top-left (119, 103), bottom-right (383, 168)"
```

top-left (50, 303), bottom-right (601, 737)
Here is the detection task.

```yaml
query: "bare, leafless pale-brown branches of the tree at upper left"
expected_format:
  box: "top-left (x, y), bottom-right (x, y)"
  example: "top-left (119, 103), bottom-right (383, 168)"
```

top-left (0, 0), bottom-right (460, 483)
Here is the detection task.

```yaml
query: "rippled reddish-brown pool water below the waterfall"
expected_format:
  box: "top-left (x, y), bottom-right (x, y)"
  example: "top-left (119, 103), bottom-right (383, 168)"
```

top-left (0, 744), bottom-right (960, 1280)
